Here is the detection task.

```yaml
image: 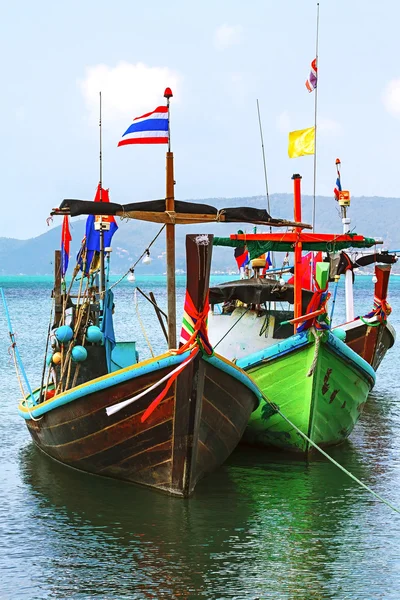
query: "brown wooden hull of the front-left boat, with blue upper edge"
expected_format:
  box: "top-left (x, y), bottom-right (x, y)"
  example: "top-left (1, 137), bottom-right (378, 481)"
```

top-left (20, 355), bottom-right (258, 497)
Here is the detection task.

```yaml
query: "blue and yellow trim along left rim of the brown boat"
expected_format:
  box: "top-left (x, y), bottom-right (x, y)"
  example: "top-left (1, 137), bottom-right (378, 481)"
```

top-left (18, 351), bottom-right (190, 421)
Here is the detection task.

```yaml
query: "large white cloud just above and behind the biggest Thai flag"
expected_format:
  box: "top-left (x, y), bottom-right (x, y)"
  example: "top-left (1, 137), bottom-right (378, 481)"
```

top-left (78, 61), bottom-right (181, 121)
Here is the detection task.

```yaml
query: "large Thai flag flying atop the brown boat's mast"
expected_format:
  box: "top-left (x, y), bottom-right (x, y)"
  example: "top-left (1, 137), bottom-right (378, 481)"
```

top-left (118, 106), bottom-right (168, 146)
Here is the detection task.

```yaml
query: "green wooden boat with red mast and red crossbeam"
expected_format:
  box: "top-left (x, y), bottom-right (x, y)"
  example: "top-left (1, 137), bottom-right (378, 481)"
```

top-left (209, 175), bottom-right (375, 453)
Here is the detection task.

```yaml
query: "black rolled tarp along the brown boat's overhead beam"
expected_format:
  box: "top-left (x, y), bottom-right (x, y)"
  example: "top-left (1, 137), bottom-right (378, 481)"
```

top-left (60, 200), bottom-right (284, 224)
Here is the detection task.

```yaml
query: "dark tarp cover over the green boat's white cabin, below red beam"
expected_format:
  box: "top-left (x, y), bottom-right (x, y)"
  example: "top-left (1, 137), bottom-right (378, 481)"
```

top-left (210, 279), bottom-right (313, 307)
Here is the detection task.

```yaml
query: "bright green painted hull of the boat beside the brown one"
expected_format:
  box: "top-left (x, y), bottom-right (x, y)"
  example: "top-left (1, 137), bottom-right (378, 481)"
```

top-left (243, 336), bottom-right (373, 453)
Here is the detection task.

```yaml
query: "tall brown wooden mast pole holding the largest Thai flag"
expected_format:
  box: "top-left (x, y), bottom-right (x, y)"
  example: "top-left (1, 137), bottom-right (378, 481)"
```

top-left (164, 88), bottom-right (176, 348)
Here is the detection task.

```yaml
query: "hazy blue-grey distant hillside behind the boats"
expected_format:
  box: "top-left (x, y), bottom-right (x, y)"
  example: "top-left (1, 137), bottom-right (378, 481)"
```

top-left (0, 194), bottom-right (400, 275)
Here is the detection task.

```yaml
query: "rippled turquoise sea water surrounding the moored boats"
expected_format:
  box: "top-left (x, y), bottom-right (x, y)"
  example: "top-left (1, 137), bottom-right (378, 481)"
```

top-left (0, 277), bottom-right (400, 600)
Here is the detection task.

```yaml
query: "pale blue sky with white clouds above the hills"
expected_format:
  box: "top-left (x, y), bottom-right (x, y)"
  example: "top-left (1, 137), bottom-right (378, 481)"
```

top-left (0, 0), bottom-right (400, 239)
